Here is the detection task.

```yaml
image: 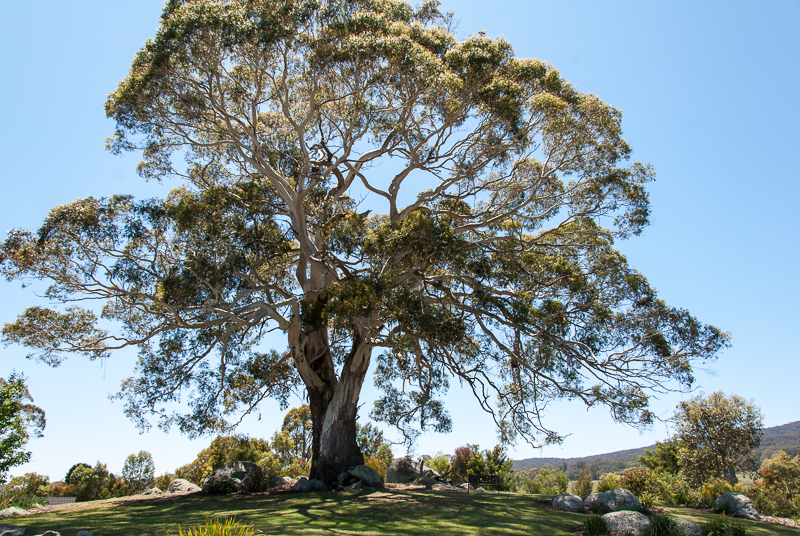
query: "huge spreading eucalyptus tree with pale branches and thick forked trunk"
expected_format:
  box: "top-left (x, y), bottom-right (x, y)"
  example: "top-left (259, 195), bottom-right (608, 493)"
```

top-left (0, 0), bottom-right (727, 482)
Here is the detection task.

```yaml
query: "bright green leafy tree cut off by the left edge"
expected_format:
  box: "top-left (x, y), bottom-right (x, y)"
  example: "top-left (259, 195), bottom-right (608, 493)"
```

top-left (0, 373), bottom-right (45, 484)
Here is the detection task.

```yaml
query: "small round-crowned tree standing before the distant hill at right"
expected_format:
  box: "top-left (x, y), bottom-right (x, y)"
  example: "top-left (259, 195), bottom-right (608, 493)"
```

top-left (675, 392), bottom-right (764, 485)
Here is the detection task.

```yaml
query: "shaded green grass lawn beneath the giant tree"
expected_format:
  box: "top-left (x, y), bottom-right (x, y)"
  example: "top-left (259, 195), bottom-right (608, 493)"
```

top-left (2, 490), bottom-right (800, 536)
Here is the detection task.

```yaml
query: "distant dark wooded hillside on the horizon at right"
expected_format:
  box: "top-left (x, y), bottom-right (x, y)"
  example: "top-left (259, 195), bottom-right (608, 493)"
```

top-left (514, 421), bottom-right (800, 480)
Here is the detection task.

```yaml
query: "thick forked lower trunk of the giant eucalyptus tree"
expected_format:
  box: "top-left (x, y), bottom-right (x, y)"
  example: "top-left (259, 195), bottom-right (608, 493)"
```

top-left (290, 306), bottom-right (371, 486)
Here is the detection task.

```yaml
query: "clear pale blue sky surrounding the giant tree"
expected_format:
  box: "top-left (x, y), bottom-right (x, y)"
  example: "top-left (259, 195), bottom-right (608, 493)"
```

top-left (0, 0), bottom-right (800, 479)
